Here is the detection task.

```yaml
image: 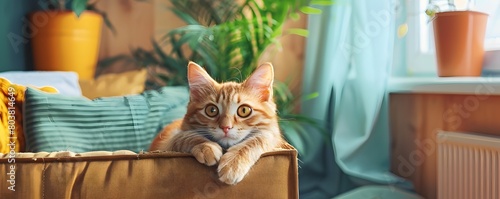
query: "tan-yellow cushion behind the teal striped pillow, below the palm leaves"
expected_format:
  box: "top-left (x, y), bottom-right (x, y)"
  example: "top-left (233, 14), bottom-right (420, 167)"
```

top-left (79, 69), bottom-right (147, 99)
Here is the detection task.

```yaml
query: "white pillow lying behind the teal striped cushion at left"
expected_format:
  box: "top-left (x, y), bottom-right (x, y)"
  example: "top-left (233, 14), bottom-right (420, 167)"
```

top-left (0, 71), bottom-right (82, 96)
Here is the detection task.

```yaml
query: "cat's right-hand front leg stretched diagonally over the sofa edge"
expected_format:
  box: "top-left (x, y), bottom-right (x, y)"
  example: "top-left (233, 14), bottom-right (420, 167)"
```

top-left (217, 136), bottom-right (275, 185)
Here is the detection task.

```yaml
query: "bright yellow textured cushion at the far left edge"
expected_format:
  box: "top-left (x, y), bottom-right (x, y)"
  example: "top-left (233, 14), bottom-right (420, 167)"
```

top-left (0, 77), bottom-right (57, 153)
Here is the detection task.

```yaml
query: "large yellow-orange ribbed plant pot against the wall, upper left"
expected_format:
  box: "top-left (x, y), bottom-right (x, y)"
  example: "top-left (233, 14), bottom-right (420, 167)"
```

top-left (29, 11), bottom-right (103, 79)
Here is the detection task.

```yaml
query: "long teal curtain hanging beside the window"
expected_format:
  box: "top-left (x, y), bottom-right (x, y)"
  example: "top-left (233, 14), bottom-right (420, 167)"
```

top-left (299, 0), bottom-right (411, 198)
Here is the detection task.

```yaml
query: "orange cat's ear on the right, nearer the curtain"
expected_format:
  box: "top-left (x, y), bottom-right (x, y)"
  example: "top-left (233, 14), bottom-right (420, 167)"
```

top-left (243, 63), bottom-right (274, 101)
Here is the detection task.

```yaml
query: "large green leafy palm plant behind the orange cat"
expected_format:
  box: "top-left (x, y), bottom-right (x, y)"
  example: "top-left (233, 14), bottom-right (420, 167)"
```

top-left (100, 0), bottom-right (333, 154)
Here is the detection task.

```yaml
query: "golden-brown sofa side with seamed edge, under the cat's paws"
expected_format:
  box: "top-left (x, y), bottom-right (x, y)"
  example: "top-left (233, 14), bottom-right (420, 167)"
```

top-left (0, 149), bottom-right (298, 199)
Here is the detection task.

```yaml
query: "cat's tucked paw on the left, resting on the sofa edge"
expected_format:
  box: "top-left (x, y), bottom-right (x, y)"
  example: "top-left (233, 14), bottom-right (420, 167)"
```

top-left (191, 142), bottom-right (222, 166)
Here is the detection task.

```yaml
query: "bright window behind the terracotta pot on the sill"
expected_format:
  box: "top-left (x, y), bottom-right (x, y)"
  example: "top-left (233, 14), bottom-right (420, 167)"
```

top-left (406, 0), bottom-right (500, 75)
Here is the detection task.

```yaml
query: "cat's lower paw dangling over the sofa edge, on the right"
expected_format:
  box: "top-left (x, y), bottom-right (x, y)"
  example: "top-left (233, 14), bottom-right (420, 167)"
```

top-left (217, 152), bottom-right (252, 185)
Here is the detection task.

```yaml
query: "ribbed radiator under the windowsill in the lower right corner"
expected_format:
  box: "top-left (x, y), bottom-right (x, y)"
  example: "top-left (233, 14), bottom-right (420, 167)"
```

top-left (437, 132), bottom-right (500, 199)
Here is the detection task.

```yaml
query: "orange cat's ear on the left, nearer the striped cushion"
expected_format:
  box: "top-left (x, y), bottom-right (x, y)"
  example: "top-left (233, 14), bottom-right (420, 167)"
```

top-left (187, 61), bottom-right (215, 98)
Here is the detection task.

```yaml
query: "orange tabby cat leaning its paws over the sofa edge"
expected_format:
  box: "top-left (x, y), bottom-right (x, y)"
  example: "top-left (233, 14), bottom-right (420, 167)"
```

top-left (150, 62), bottom-right (284, 184)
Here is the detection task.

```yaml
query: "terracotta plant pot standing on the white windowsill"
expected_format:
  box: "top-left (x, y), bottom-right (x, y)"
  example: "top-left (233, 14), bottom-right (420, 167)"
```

top-left (433, 11), bottom-right (488, 77)
